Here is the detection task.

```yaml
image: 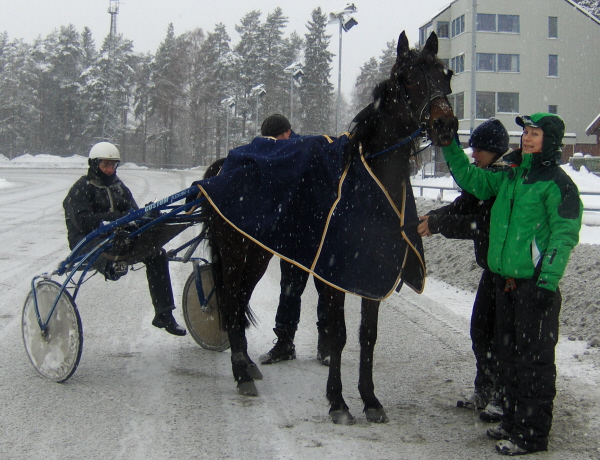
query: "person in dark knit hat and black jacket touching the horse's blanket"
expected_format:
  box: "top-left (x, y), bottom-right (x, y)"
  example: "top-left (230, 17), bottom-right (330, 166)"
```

top-left (418, 118), bottom-right (509, 422)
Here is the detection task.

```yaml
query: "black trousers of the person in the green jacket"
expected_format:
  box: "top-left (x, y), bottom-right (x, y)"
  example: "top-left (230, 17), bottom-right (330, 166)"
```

top-left (494, 275), bottom-right (561, 451)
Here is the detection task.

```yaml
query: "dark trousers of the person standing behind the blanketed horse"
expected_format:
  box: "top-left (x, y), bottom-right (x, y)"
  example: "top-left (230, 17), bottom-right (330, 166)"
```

top-left (275, 259), bottom-right (327, 331)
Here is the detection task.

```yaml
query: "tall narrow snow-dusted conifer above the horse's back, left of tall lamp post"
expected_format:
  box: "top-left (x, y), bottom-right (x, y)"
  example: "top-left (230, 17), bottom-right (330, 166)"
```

top-left (300, 8), bottom-right (334, 134)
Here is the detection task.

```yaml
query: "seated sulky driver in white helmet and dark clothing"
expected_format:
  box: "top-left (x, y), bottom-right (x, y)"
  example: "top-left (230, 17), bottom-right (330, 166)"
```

top-left (63, 142), bottom-right (186, 336)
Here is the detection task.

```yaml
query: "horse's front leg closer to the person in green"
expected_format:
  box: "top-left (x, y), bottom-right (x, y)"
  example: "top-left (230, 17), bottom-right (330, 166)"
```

top-left (358, 299), bottom-right (389, 423)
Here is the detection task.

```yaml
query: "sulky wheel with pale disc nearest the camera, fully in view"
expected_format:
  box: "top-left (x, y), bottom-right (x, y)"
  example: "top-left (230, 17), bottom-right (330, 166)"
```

top-left (21, 280), bottom-right (83, 383)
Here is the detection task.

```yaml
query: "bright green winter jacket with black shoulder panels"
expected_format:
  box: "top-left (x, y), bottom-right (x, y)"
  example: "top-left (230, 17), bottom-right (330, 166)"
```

top-left (443, 140), bottom-right (583, 291)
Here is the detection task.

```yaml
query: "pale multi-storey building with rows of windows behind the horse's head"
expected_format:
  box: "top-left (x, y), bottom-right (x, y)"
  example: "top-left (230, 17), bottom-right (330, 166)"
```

top-left (419, 0), bottom-right (600, 157)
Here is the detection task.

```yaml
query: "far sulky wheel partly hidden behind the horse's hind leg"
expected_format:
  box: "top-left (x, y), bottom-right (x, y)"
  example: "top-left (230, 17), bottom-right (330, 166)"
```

top-left (182, 265), bottom-right (229, 351)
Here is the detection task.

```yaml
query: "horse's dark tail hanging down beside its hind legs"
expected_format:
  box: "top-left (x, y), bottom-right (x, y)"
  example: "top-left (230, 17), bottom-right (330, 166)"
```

top-left (201, 158), bottom-right (257, 330)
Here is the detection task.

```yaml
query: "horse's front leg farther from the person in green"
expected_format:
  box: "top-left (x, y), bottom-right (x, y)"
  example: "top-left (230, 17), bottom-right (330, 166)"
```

top-left (324, 286), bottom-right (355, 425)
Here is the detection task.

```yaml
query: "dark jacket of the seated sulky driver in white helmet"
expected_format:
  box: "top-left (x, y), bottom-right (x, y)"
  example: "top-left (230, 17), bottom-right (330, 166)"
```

top-left (63, 168), bottom-right (139, 249)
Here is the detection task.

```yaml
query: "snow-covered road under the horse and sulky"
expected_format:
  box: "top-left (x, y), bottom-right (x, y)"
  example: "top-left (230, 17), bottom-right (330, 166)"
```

top-left (0, 168), bottom-right (600, 460)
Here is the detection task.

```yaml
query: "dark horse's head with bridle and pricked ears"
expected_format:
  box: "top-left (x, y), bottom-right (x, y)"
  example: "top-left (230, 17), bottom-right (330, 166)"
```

top-left (391, 32), bottom-right (458, 145)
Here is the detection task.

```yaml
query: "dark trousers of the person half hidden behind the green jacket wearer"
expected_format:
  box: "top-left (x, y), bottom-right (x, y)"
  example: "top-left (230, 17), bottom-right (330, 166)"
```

top-left (471, 270), bottom-right (496, 399)
